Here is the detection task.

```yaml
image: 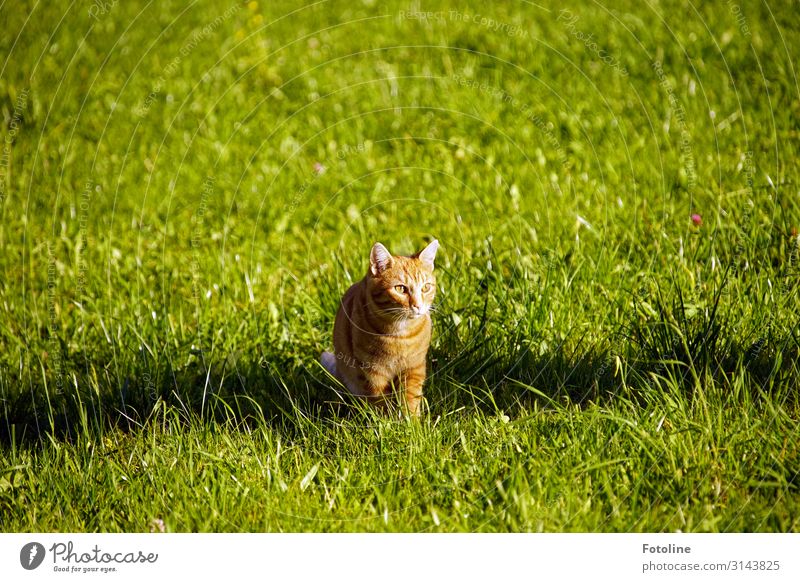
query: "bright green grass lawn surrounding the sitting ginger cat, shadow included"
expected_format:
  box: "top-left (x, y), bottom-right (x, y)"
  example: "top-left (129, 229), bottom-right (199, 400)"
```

top-left (0, 0), bottom-right (800, 532)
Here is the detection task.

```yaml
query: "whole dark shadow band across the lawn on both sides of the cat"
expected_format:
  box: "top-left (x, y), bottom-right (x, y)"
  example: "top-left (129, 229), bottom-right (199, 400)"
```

top-left (0, 280), bottom-right (800, 446)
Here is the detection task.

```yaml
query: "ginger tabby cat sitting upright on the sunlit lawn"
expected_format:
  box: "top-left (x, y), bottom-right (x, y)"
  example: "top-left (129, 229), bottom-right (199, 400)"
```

top-left (321, 240), bottom-right (439, 416)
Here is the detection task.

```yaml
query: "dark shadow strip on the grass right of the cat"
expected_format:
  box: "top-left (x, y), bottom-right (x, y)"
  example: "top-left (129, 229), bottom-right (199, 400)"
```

top-left (428, 278), bottom-right (800, 412)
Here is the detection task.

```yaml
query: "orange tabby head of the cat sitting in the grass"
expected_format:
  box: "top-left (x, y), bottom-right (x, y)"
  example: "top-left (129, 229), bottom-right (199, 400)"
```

top-left (367, 240), bottom-right (439, 319)
